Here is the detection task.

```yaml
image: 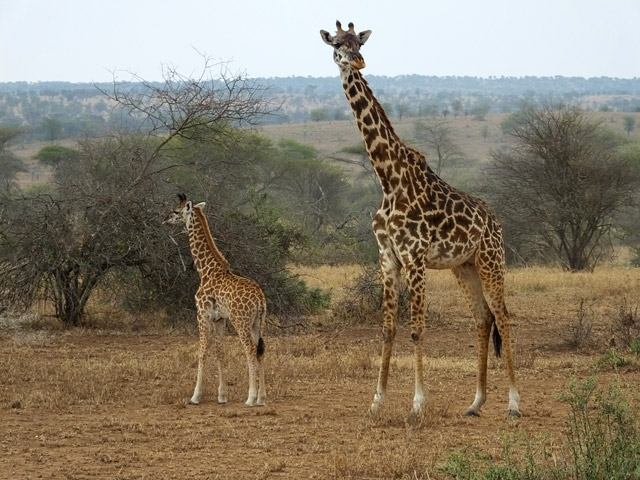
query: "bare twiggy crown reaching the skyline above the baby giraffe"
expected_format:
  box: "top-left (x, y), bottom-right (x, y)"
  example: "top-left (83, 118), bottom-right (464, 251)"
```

top-left (98, 58), bottom-right (274, 188)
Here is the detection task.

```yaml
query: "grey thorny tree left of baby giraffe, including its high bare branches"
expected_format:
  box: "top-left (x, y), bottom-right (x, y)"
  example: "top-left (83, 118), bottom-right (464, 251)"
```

top-left (0, 60), bottom-right (271, 325)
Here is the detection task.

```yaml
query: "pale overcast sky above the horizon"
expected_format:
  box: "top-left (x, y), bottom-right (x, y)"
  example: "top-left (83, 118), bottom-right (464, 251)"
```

top-left (0, 0), bottom-right (640, 82)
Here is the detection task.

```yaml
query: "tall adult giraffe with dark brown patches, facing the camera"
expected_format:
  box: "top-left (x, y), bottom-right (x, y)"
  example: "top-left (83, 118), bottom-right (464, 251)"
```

top-left (320, 22), bottom-right (520, 417)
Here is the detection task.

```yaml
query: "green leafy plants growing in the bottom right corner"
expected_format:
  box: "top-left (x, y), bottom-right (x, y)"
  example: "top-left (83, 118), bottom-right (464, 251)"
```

top-left (440, 377), bottom-right (640, 480)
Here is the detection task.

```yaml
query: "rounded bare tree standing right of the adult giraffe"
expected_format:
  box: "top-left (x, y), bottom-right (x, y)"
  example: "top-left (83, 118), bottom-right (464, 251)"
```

top-left (486, 105), bottom-right (639, 271)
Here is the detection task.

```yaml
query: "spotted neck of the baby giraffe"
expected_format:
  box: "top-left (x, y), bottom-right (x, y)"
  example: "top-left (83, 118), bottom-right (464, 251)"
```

top-left (187, 205), bottom-right (229, 279)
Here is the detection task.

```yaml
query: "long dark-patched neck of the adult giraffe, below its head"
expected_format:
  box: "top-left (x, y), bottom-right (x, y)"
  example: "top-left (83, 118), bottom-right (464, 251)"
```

top-left (340, 70), bottom-right (430, 195)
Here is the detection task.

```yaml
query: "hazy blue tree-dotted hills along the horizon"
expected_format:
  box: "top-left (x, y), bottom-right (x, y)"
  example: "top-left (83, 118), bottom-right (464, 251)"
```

top-left (0, 73), bottom-right (640, 140)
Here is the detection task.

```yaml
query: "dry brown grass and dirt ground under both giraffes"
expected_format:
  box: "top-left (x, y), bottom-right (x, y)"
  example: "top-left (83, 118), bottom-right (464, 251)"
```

top-left (0, 266), bottom-right (640, 479)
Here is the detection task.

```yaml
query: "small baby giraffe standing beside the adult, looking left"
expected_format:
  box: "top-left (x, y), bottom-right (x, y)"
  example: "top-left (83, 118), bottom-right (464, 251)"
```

top-left (163, 193), bottom-right (267, 406)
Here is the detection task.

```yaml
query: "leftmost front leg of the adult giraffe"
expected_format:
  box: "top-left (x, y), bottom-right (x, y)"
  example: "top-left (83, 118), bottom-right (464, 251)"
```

top-left (371, 255), bottom-right (400, 412)
